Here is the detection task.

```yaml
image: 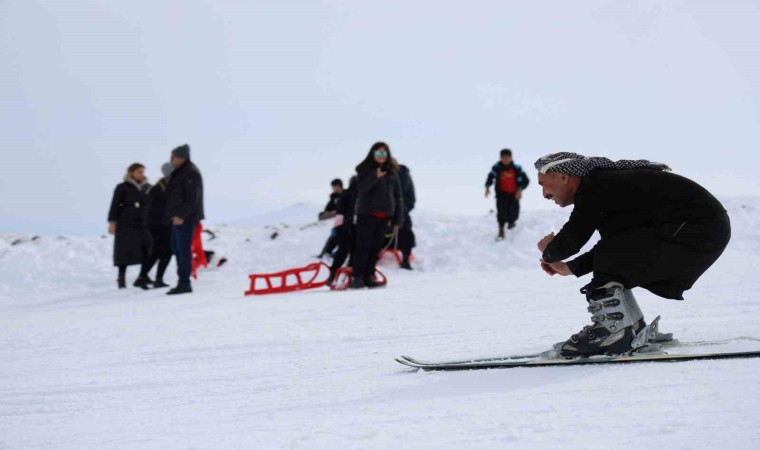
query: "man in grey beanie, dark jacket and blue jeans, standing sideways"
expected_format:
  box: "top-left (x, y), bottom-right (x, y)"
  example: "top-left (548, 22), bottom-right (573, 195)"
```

top-left (164, 144), bottom-right (205, 295)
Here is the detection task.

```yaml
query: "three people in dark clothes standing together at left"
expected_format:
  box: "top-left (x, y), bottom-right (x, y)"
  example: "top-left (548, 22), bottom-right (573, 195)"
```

top-left (108, 144), bottom-right (205, 295)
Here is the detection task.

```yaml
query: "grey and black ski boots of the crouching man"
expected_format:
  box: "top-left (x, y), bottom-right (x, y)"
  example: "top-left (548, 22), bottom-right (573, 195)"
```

top-left (560, 282), bottom-right (646, 357)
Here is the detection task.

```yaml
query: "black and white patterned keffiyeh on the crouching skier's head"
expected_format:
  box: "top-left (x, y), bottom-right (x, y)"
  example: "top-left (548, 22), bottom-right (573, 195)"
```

top-left (535, 152), bottom-right (670, 177)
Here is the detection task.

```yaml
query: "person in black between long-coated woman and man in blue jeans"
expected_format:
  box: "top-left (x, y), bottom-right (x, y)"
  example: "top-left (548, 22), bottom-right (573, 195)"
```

top-left (140, 163), bottom-right (174, 289)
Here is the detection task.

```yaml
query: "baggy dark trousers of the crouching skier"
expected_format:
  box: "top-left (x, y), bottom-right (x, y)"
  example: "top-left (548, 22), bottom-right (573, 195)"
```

top-left (589, 213), bottom-right (731, 300)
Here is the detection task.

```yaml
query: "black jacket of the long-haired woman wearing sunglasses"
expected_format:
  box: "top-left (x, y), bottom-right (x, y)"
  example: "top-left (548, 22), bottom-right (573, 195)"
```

top-left (356, 166), bottom-right (404, 225)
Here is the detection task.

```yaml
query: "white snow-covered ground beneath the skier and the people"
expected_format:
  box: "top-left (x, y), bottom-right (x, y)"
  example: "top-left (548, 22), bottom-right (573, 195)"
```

top-left (0, 198), bottom-right (760, 450)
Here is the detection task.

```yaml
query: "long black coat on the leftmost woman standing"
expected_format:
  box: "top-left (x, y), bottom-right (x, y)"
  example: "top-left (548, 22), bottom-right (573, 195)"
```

top-left (108, 181), bottom-right (152, 266)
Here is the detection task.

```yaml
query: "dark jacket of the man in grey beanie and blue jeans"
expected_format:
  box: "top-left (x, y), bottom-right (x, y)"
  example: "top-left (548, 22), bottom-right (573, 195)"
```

top-left (164, 161), bottom-right (206, 222)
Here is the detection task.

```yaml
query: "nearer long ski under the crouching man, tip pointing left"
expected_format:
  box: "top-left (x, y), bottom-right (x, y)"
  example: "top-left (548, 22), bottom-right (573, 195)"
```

top-left (396, 350), bottom-right (760, 371)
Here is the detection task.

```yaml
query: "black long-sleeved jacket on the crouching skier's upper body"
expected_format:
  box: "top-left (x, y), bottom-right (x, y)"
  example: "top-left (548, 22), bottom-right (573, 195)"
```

top-left (543, 169), bottom-right (726, 276)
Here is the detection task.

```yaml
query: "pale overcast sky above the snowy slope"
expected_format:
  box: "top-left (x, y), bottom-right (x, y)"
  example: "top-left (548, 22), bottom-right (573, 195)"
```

top-left (0, 0), bottom-right (760, 234)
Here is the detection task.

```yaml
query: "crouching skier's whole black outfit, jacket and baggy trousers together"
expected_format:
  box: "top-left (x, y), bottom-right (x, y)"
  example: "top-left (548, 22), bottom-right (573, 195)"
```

top-left (543, 169), bottom-right (731, 300)
